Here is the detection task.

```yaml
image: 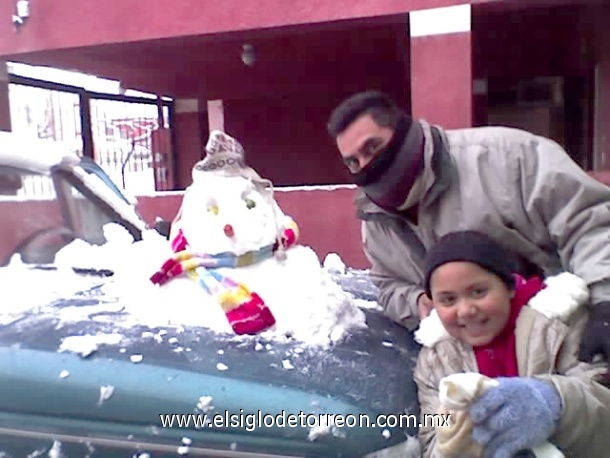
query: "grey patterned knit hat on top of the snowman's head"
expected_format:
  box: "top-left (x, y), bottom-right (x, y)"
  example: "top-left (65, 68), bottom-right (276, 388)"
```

top-left (193, 130), bottom-right (270, 186)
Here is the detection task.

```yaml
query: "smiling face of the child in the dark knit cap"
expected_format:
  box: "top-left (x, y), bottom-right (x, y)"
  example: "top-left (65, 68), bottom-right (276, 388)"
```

top-left (430, 261), bottom-right (514, 347)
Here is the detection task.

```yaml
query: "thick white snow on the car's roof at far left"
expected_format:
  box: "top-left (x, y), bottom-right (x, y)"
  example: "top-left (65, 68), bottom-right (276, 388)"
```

top-left (0, 132), bottom-right (79, 174)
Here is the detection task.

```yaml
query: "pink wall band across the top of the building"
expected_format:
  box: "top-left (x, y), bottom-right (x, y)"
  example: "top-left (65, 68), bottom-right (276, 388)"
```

top-left (0, 0), bottom-right (487, 55)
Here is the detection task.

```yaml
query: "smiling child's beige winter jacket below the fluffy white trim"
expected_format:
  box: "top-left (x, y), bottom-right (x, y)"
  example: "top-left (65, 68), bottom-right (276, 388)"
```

top-left (414, 307), bottom-right (610, 458)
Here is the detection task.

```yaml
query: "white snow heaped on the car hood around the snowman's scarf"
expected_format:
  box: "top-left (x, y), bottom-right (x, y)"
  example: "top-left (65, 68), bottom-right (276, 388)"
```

top-left (0, 223), bottom-right (366, 352)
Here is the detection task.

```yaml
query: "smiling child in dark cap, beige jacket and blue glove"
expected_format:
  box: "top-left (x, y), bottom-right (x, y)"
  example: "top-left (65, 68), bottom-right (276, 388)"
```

top-left (415, 231), bottom-right (610, 458)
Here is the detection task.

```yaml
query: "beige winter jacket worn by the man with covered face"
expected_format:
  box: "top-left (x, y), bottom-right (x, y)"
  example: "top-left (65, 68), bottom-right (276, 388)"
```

top-left (356, 121), bottom-right (610, 329)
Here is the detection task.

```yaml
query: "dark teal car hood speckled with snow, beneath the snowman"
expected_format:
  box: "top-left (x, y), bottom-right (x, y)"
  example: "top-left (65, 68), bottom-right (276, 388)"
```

top-left (0, 274), bottom-right (419, 456)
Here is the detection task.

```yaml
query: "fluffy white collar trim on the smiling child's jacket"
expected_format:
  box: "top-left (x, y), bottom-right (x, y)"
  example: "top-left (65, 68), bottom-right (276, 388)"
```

top-left (414, 272), bottom-right (589, 348)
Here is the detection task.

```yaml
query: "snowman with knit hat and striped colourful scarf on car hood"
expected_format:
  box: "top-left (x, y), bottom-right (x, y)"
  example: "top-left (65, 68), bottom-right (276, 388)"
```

top-left (151, 131), bottom-right (366, 343)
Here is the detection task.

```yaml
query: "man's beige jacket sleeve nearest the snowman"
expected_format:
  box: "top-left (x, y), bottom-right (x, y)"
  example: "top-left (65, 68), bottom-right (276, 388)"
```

top-left (362, 221), bottom-right (424, 330)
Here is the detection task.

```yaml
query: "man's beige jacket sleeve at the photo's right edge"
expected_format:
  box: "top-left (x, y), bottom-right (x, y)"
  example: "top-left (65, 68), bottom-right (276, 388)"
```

top-left (507, 136), bottom-right (610, 304)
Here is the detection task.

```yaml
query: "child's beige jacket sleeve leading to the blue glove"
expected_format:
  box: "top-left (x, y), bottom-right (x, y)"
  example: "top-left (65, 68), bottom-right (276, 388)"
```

top-left (536, 313), bottom-right (610, 457)
